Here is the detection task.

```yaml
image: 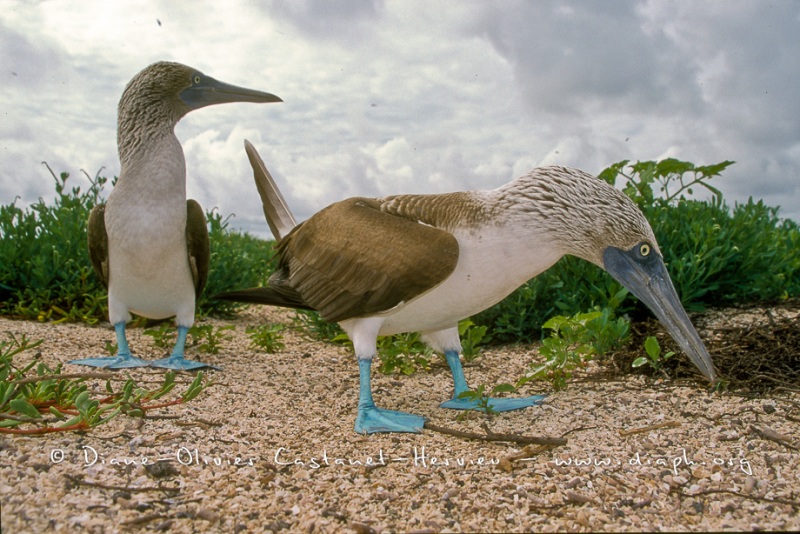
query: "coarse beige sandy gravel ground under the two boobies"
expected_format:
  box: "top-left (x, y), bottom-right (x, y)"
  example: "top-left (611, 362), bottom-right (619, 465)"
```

top-left (0, 308), bottom-right (800, 534)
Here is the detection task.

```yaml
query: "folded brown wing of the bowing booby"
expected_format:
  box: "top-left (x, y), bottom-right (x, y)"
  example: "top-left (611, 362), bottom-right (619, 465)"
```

top-left (278, 198), bottom-right (458, 322)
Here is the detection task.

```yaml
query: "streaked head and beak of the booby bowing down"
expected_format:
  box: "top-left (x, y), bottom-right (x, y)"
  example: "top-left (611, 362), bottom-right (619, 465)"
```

top-left (510, 167), bottom-right (716, 382)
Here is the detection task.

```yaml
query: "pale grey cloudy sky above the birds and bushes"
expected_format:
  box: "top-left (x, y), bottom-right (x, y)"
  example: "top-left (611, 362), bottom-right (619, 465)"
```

top-left (0, 0), bottom-right (800, 236)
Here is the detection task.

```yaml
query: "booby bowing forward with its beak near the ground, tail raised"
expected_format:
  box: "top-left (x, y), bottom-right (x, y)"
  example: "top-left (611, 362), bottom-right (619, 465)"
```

top-left (217, 142), bottom-right (716, 433)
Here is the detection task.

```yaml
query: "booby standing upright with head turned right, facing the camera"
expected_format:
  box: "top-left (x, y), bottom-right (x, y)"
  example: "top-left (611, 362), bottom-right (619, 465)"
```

top-left (70, 62), bottom-right (281, 370)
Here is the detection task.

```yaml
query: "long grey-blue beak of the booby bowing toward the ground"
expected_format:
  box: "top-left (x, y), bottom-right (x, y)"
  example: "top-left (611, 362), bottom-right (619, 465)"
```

top-left (603, 247), bottom-right (716, 383)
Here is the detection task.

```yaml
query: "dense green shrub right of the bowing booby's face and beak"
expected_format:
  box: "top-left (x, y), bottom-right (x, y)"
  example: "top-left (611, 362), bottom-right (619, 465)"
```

top-left (646, 199), bottom-right (800, 310)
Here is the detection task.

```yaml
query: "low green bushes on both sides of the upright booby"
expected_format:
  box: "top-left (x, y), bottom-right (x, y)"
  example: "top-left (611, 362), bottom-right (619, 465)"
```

top-left (0, 167), bottom-right (273, 323)
